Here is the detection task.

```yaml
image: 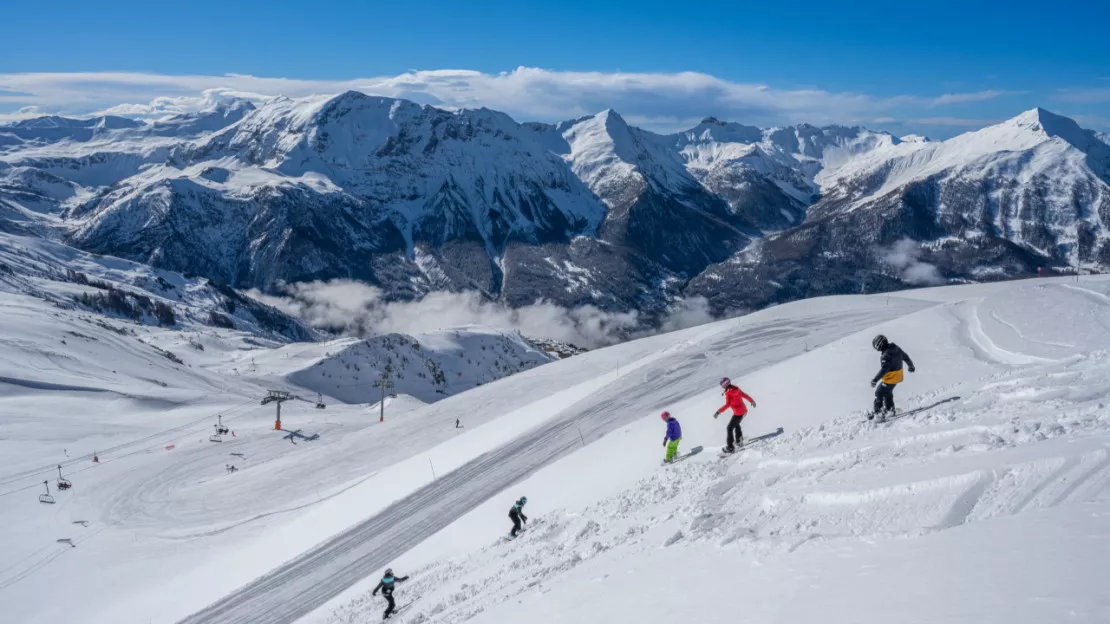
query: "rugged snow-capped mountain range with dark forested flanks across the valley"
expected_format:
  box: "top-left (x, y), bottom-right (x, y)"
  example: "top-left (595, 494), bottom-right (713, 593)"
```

top-left (0, 97), bottom-right (1110, 312)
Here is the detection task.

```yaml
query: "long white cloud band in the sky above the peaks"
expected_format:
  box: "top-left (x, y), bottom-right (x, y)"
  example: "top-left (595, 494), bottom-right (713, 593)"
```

top-left (0, 68), bottom-right (1038, 130)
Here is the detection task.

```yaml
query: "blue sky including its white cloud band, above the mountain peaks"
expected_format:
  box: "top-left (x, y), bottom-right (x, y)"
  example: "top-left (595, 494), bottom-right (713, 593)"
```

top-left (0, 0), bottom-right (1110, 137)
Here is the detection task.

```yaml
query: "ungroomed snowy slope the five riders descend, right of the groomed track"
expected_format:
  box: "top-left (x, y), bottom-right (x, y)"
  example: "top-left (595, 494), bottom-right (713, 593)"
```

top-left (317, 274), bottom-right (1110, 624)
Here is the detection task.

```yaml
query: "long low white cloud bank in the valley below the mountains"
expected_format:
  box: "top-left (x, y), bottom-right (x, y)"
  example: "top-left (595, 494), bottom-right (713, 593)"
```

top-left (250, 280), bottom-right (715, 348)
